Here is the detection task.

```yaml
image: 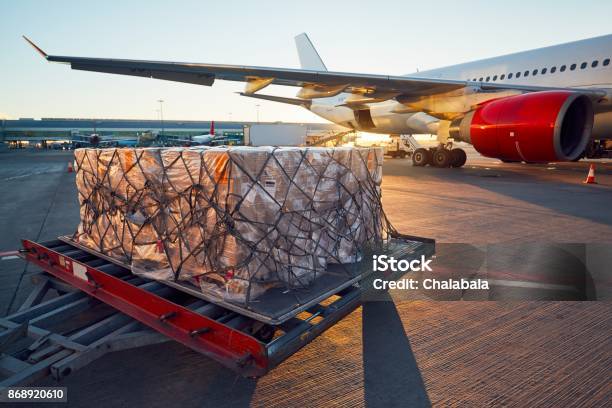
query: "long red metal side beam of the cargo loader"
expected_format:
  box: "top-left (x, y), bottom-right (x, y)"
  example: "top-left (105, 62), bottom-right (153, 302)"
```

top-left (22, 240), bottom-right (269, 376)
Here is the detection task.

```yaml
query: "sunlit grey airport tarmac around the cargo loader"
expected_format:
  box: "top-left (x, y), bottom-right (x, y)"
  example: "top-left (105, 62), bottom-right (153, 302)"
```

top-left (0, 150), bottom-right (612, 407)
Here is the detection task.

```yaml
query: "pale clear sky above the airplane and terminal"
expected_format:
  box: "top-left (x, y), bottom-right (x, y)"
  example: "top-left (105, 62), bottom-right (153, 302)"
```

top-left (0, 0), bottom-right (612, 122)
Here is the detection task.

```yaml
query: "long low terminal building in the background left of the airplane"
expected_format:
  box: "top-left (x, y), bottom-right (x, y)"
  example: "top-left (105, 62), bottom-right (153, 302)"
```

top-left (0, 118), bottom-right (338, 148)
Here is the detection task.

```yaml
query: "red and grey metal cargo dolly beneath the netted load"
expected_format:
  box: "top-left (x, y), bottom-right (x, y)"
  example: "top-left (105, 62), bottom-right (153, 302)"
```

top-left (0, 235), bottom-right (435, 388)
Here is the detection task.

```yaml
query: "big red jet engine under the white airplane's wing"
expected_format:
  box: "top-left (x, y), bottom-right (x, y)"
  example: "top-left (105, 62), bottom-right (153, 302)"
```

top-left (450, 91), bottom-right (593, 162)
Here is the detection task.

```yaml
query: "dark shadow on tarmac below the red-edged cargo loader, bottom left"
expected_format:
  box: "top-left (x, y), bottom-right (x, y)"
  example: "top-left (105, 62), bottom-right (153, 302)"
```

top-left (33, 341), bottom-right (258, 408)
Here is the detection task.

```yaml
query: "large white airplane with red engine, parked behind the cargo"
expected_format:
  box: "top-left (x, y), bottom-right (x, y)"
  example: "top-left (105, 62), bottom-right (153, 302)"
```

top-left (24, 33), bottom-right (612, 167)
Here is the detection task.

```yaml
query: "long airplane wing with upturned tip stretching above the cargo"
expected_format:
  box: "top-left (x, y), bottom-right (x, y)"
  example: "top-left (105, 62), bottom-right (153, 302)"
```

top-left (24, 36), bottom-right (606, 103)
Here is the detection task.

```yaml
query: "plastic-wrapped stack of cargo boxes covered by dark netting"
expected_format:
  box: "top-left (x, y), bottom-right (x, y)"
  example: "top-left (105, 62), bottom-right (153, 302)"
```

top-left (73, 147), bottom-right (392, 304)
